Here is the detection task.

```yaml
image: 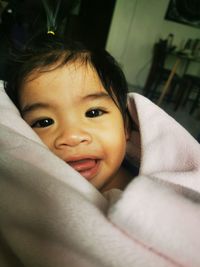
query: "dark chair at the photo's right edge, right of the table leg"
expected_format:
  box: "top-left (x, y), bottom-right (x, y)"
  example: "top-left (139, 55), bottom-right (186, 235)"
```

top-left (174, 74), bottom-right (200, 114)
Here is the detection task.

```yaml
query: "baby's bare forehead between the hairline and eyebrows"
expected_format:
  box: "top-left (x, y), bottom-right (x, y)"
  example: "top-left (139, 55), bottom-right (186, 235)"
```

top-left (21, 61), bottom-right (105, 100)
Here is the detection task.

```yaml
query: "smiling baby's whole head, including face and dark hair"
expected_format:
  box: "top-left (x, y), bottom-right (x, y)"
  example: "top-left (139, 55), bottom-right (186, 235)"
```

top-left (5, 36), bottom-right (131, 193)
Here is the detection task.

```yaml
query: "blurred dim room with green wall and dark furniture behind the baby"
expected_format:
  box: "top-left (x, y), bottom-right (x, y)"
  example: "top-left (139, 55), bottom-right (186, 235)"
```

top-left (0, 0), bottom-right (200, 140)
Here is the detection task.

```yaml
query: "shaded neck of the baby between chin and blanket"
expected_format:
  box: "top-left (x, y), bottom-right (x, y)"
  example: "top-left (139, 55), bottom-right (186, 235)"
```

top-left (100, 166), bottom-right (133, 193)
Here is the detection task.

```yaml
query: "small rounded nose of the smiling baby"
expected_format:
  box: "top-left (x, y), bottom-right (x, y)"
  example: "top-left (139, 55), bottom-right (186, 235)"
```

top-left (55, 126), bottom-right (92, 149)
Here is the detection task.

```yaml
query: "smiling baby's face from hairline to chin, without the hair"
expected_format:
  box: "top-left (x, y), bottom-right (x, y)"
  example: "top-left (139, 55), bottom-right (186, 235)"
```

top-left (20, 63), bottom-right (127, 190)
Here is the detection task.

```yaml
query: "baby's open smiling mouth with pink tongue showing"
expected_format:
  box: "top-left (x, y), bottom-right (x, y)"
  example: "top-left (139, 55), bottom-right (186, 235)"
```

top-left (67, 158), bottom-right (100, 181)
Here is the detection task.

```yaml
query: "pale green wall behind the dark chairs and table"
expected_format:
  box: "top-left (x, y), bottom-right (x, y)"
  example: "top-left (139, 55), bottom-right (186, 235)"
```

top-left (106, 0), bottom-right (200, 90)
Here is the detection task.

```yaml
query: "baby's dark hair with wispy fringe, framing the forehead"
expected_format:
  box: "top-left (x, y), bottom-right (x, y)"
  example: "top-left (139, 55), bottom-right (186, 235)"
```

top-left (5, 34), bottom-right (128, 117)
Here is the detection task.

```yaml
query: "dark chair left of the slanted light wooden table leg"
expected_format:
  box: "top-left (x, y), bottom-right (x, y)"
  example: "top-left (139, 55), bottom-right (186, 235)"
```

top-left (143, 39), bottom-right (180, 100)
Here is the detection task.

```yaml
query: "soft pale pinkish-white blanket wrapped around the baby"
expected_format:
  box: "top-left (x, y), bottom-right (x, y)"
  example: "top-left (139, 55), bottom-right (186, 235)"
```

top-left (0, 82), bottom-right (200, 267)
